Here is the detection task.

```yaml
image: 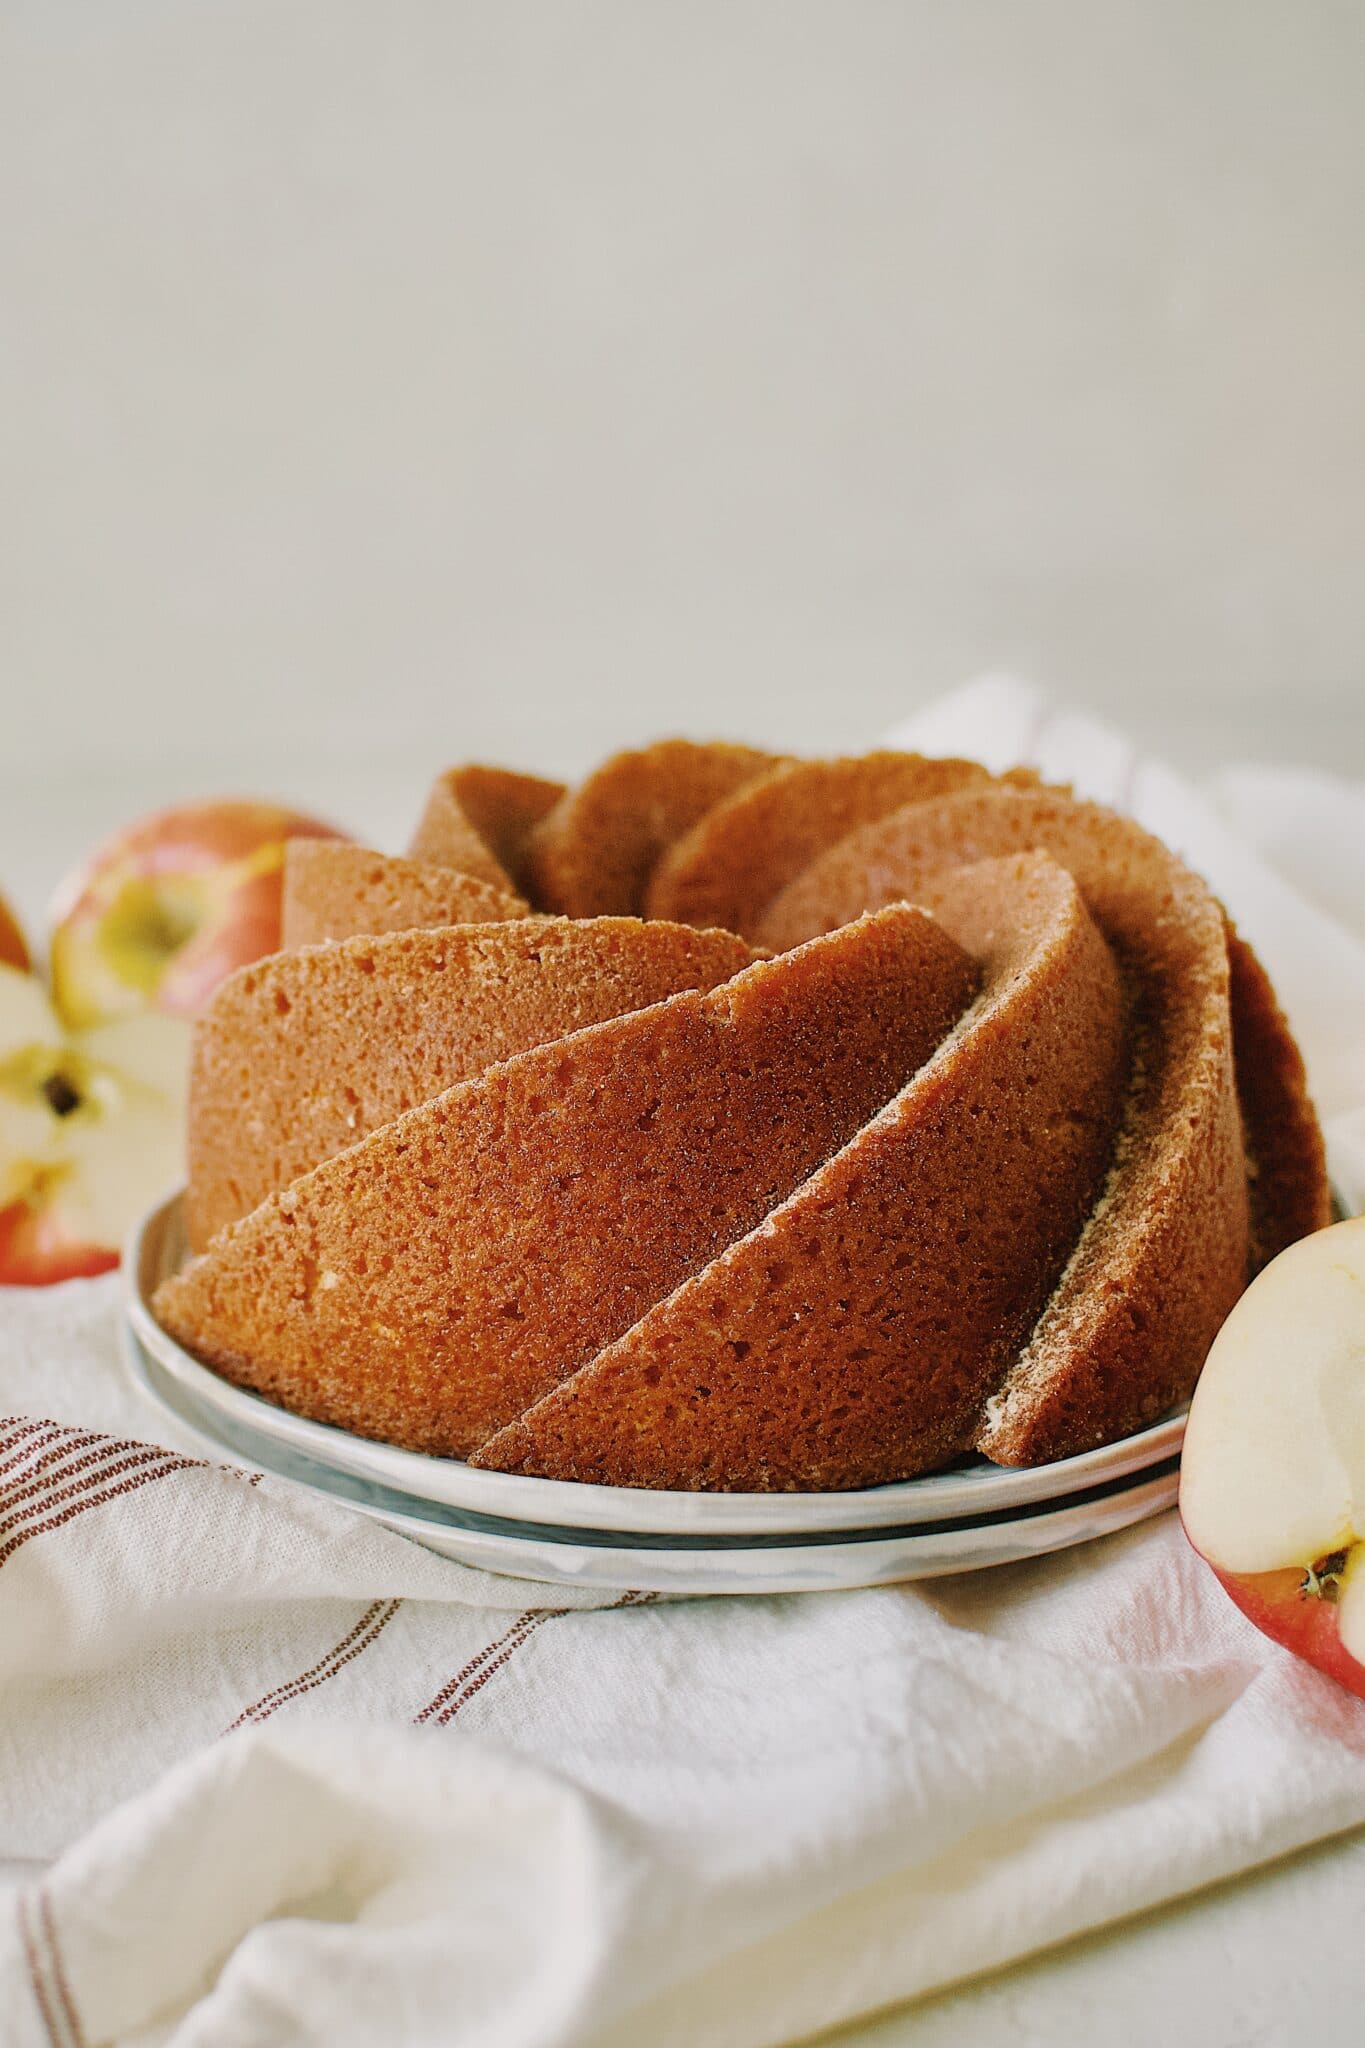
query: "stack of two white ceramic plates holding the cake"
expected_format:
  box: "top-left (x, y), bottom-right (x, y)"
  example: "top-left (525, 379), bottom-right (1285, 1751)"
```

top-left (125, 1196), bottom-right (1185, 1593)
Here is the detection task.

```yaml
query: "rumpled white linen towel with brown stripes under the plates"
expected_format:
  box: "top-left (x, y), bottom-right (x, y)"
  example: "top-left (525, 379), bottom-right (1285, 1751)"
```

top-left (0, 680), bottom-right (1365, 2048)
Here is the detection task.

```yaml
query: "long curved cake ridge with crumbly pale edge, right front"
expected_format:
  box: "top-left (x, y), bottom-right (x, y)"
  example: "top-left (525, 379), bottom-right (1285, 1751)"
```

top-left (763, 791), bottom-right (1248, 1464)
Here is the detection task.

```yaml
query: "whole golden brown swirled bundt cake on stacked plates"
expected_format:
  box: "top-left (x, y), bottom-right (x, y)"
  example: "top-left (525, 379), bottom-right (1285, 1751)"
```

top-left (156, 741), bottom-right (1330, 1489)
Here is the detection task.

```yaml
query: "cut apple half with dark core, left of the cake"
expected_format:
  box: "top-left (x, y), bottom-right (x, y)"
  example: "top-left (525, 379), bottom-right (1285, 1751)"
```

top-left (0, 967), bottom-right (188, 1286)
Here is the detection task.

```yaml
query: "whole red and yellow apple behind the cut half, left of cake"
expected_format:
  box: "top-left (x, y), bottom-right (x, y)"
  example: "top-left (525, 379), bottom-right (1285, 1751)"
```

top-left (51, 801), bottom-right (340, 1028)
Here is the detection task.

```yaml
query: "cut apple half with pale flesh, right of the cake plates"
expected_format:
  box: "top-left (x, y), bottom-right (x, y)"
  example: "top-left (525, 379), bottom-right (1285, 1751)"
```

top-left (1181, 1217), bottom-right (1365, 1698)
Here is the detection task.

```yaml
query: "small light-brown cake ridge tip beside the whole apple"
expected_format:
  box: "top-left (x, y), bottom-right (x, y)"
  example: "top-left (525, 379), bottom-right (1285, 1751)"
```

top-left (280, 840), bottom-right (530, 952)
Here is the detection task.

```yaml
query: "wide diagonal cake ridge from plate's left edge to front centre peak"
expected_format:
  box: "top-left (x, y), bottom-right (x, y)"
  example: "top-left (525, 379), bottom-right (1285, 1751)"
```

top-left (156, 907), bottom-right (976, 1454)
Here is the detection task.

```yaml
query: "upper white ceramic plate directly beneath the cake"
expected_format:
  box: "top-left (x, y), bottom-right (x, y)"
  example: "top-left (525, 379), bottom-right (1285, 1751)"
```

top-left (125, 1196), bottom-right (1185, 1540)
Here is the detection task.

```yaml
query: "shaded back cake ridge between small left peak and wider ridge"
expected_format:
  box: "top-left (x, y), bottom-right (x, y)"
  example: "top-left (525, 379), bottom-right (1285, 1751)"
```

top-left (519, 739), bottom-right (774, 930)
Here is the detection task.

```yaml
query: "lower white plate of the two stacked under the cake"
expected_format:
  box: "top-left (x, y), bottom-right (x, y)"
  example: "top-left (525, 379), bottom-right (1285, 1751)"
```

top-left (123, 1323), bottom-right (1179, 1595)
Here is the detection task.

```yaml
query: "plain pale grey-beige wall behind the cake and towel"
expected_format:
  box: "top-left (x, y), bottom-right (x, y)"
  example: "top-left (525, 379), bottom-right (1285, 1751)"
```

top-left (0, 0), bottom-right (1365, 921)
